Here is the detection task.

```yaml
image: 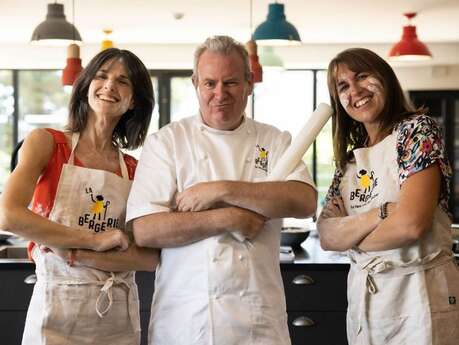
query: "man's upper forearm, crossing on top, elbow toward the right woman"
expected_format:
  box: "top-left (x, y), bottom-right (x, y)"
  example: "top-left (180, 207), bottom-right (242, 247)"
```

top-left (222, 181), bottom-right (317, 218)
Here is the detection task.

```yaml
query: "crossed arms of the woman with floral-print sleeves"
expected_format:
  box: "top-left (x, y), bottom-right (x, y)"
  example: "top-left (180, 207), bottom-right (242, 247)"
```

top-left (317, 164), bottom-right (441, 251)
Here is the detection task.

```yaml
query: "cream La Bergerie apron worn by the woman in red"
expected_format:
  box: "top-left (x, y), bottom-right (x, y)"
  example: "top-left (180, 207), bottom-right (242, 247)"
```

top-left (22, 133), bottom-right (140, 345)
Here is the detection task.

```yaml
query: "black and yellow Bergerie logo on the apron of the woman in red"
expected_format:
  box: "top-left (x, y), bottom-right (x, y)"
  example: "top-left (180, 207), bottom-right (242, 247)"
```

top-left (78, 187), bottom-right (120, 232)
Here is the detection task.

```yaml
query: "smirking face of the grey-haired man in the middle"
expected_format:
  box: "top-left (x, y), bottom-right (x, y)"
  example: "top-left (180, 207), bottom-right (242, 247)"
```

top-left (193, 50), bottom-right (253, 130)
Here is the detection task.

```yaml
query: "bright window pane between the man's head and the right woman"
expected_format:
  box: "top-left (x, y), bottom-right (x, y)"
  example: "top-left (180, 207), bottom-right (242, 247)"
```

top-left (254, 69), bottom-right (313, 174)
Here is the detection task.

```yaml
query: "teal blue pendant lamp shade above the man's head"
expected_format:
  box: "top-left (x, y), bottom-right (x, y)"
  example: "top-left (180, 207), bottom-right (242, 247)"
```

top-left (253, 2), bottom-right (301, 46)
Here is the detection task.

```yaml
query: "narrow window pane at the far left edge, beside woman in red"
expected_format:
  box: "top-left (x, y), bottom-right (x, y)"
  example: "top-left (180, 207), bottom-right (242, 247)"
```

top-left (0, 71), bottom-right (14, 191)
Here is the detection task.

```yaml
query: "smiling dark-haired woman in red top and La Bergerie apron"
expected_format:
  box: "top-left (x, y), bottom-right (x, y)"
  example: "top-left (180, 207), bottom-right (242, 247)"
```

top-left (0, 48), bottom-right (158, 345)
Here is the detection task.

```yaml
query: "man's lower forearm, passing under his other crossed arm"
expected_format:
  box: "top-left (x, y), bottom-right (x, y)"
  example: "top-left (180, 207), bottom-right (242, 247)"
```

top-left (132, 208), bottom-right (231, 248)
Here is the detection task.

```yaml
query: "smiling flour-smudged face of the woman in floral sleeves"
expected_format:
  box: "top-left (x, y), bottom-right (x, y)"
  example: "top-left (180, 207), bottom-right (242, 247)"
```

top-left (336, 64), bottom-right (385, 131)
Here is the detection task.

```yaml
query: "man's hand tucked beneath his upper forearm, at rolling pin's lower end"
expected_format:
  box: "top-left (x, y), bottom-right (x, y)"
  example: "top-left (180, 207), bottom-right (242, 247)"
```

top-left (228, 207), bottom-right (268, 240)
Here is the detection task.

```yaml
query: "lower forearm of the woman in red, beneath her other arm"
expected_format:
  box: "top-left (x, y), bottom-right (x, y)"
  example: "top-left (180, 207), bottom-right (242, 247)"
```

top-left (75, 244), bottom-right (159, 272)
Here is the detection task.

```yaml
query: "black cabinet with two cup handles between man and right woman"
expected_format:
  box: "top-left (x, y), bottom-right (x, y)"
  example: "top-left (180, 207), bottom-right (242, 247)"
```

top-left (281, 263), bottom-right (349, 345)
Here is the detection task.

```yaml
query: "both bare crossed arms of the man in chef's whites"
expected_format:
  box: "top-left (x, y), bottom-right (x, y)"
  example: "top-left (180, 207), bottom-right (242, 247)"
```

top-left (133, 181), bottom-right (317, 248)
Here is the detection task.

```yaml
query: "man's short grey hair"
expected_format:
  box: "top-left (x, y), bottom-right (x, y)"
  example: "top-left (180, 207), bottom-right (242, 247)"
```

top-left (191, 36), bottom-right (251, 80)
